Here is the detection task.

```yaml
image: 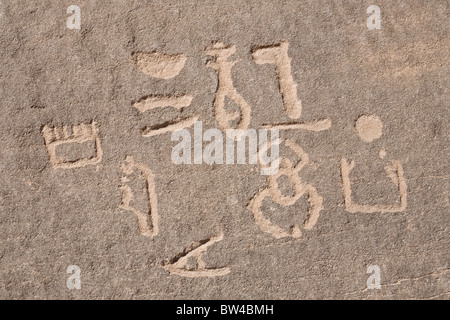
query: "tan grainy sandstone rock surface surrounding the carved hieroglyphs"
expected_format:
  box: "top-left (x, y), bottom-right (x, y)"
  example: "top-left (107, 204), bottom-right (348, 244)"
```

top-left (0, 0), bottom-right (450, 299)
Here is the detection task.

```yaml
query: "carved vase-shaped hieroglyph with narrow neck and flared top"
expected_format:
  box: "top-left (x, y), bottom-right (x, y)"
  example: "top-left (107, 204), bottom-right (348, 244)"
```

top-left (205, 42), bottom-right (251, 132)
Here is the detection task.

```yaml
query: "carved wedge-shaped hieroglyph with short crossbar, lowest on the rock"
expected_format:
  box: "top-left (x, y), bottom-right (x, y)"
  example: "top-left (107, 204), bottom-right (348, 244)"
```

top-left (164, 233), bottom-right (230, 278)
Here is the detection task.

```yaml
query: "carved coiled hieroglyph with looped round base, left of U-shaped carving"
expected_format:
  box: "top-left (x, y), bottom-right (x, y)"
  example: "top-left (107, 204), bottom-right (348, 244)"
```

top-left (247, 140), bottom-right (323, 238)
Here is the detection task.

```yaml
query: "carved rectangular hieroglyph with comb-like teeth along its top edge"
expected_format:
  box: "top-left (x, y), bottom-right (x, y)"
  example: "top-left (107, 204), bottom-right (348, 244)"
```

top-left (42, 121), bottom-right (103, 169)
